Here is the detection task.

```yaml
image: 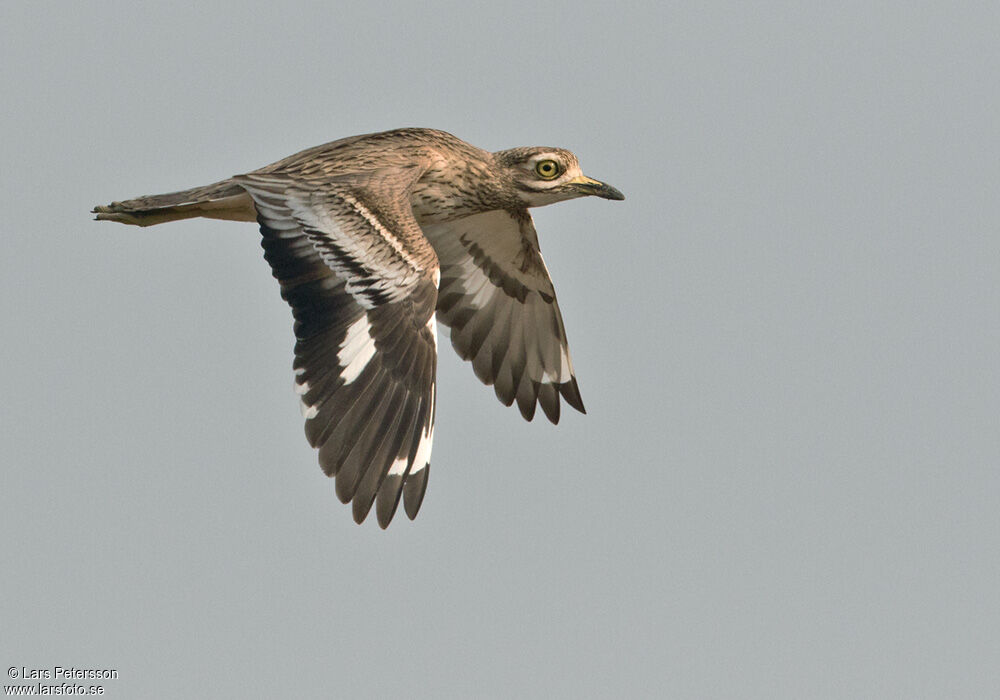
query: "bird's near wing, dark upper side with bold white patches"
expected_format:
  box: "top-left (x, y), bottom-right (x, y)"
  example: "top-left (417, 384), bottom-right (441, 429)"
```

top-left (234, 168), bottom-right (439, 527)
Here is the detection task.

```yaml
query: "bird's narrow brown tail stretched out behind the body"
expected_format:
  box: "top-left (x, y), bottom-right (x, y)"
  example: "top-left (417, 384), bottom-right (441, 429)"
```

top-left (93, 180), bottom-right (257, 226)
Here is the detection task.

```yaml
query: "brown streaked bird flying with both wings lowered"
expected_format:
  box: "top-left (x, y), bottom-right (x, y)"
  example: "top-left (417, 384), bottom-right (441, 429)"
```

top-left (93, 129), bottom-right (624, 528)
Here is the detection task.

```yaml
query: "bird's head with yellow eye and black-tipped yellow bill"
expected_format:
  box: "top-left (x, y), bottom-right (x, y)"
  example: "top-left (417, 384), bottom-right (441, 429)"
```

top-left (493, 146), bottom-right (625, 207)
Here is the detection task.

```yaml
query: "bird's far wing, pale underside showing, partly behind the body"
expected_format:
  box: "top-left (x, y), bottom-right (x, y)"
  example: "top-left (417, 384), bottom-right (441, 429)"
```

top-left (423, 210), bottom-right (585, 423)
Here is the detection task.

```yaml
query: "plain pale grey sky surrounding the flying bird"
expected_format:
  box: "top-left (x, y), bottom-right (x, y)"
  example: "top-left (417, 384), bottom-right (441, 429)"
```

top-left (0, 0), bottom-right (1000, 698)
